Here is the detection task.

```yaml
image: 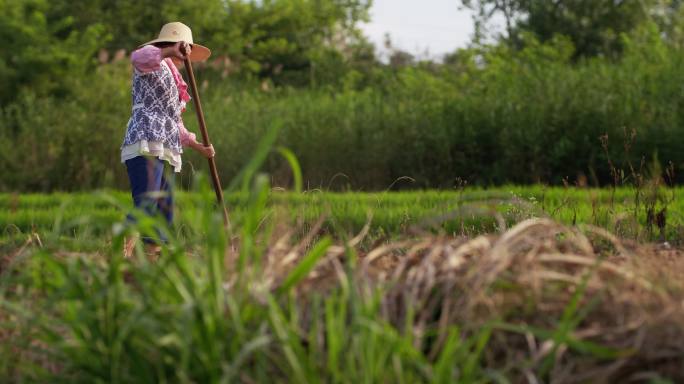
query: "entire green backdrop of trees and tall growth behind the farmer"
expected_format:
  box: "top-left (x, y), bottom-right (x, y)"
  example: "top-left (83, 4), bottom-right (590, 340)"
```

top-left (6, 0), bottom-right (684, 191)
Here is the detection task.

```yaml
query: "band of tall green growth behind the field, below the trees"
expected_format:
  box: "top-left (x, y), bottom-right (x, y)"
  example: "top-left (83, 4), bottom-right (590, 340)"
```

top-left (6, 24), bottom-right (684, 191)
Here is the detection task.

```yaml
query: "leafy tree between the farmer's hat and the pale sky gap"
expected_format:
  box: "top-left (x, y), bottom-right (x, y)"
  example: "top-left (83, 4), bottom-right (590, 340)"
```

top-left (215, 0), bottom-right (371, 83)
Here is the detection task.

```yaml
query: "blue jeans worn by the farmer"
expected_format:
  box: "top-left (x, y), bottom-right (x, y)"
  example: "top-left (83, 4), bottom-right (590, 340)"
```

top-left (126, 156), bottom-right (173, 243)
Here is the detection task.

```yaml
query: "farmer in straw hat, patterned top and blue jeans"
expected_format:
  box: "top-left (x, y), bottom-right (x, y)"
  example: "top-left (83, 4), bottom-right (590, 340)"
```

top-left (121, 22), bottom-right (214, 257)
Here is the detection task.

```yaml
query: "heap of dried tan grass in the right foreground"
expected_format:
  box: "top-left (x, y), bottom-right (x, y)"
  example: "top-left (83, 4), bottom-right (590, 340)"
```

top-left (255, 219), bottom-right (684, 382)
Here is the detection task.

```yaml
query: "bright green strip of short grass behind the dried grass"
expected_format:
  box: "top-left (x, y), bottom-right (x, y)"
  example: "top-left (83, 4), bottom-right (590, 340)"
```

top-left (0, 186), bottom-right (684, 248)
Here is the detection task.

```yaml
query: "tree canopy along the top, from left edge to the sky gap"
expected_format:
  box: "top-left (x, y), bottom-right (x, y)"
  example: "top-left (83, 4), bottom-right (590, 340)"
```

top-left (0, 0), bottom-right (370, 105)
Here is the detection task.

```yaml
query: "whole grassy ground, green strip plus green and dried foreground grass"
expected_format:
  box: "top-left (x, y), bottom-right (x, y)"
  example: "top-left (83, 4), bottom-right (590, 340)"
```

top-left (0, 185), bottom-right (684, 383)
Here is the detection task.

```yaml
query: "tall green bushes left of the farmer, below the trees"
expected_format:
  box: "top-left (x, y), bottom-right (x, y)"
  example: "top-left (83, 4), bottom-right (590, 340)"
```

top-left (0, 62), bottom-right (130, 190)
